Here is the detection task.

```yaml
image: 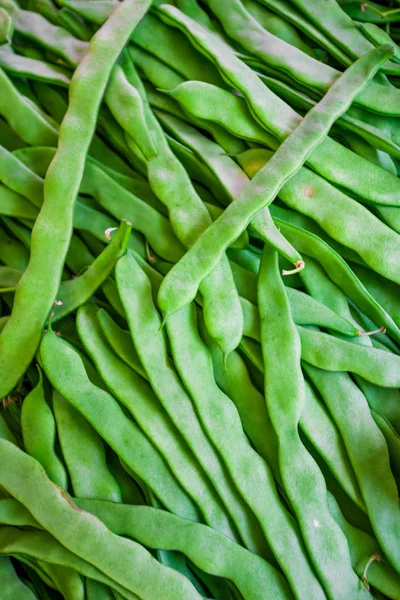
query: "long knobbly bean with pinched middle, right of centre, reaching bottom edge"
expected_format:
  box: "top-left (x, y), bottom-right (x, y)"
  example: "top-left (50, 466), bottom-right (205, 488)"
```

top-left (258, 248), bottom-right (362, 598)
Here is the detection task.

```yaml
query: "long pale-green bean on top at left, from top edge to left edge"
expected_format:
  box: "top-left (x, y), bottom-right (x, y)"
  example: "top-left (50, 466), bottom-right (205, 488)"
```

top-left (0, 0), bottom-right (153, 396)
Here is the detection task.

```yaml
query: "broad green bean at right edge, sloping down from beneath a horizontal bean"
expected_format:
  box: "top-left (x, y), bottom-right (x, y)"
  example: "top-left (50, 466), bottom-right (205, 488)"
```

top-left (304, 364), bottom-right (400, 571)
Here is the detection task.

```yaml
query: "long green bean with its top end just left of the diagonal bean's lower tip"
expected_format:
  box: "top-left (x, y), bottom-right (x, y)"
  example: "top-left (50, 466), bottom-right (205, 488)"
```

top-left (116, 255), bottom-right (266, 553)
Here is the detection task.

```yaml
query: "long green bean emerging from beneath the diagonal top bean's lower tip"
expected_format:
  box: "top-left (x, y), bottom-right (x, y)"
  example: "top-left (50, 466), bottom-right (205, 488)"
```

top-left (167, 306), bottom-right (330, 596)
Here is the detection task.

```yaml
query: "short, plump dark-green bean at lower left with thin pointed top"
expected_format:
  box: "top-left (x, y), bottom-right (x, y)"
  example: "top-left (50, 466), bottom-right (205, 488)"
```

top-left (21, 370), bottom-right (68, 489)
